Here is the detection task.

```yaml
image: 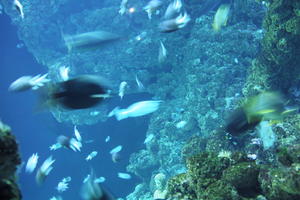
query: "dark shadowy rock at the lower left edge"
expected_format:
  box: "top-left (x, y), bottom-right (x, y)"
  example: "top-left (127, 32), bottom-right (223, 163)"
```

top-left (0, 121), bottom-right (21, 200)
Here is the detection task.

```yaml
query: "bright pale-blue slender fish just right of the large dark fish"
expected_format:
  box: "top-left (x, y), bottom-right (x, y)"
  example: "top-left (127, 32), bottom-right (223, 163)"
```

top-left (111, 100), bottom-right (162, 121)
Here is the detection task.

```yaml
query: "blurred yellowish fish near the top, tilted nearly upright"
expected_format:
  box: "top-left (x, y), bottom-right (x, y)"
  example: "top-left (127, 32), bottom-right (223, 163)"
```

top-left (212, 4), bottom-right (230, 32)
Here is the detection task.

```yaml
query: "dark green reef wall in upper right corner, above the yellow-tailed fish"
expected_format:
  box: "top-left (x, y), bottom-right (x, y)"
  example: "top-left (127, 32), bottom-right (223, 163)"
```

top-left (243, 0), bottom-right (300, 96)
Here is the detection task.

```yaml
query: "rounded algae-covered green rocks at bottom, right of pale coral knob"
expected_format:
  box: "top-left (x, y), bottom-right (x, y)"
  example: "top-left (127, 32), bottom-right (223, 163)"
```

top-left (167, 152), bottom-right (260, 200)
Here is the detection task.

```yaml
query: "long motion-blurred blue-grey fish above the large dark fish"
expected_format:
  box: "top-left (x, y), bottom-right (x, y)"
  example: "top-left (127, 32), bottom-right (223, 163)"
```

top-left (63, 30), bottom-right (121, 52)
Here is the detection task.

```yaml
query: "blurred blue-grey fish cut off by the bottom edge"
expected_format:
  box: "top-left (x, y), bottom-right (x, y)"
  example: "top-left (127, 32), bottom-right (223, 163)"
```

top-left (80, 170), bottom-right (115, 200)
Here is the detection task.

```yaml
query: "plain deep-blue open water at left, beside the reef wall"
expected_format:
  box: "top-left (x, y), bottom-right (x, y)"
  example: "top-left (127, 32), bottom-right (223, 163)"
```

top-left (0, 15), bottom-right (149, 200)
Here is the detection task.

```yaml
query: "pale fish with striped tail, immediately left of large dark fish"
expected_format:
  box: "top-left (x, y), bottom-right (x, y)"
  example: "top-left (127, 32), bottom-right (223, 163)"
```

top-left (8, 74), bottom-right (50, 92)
